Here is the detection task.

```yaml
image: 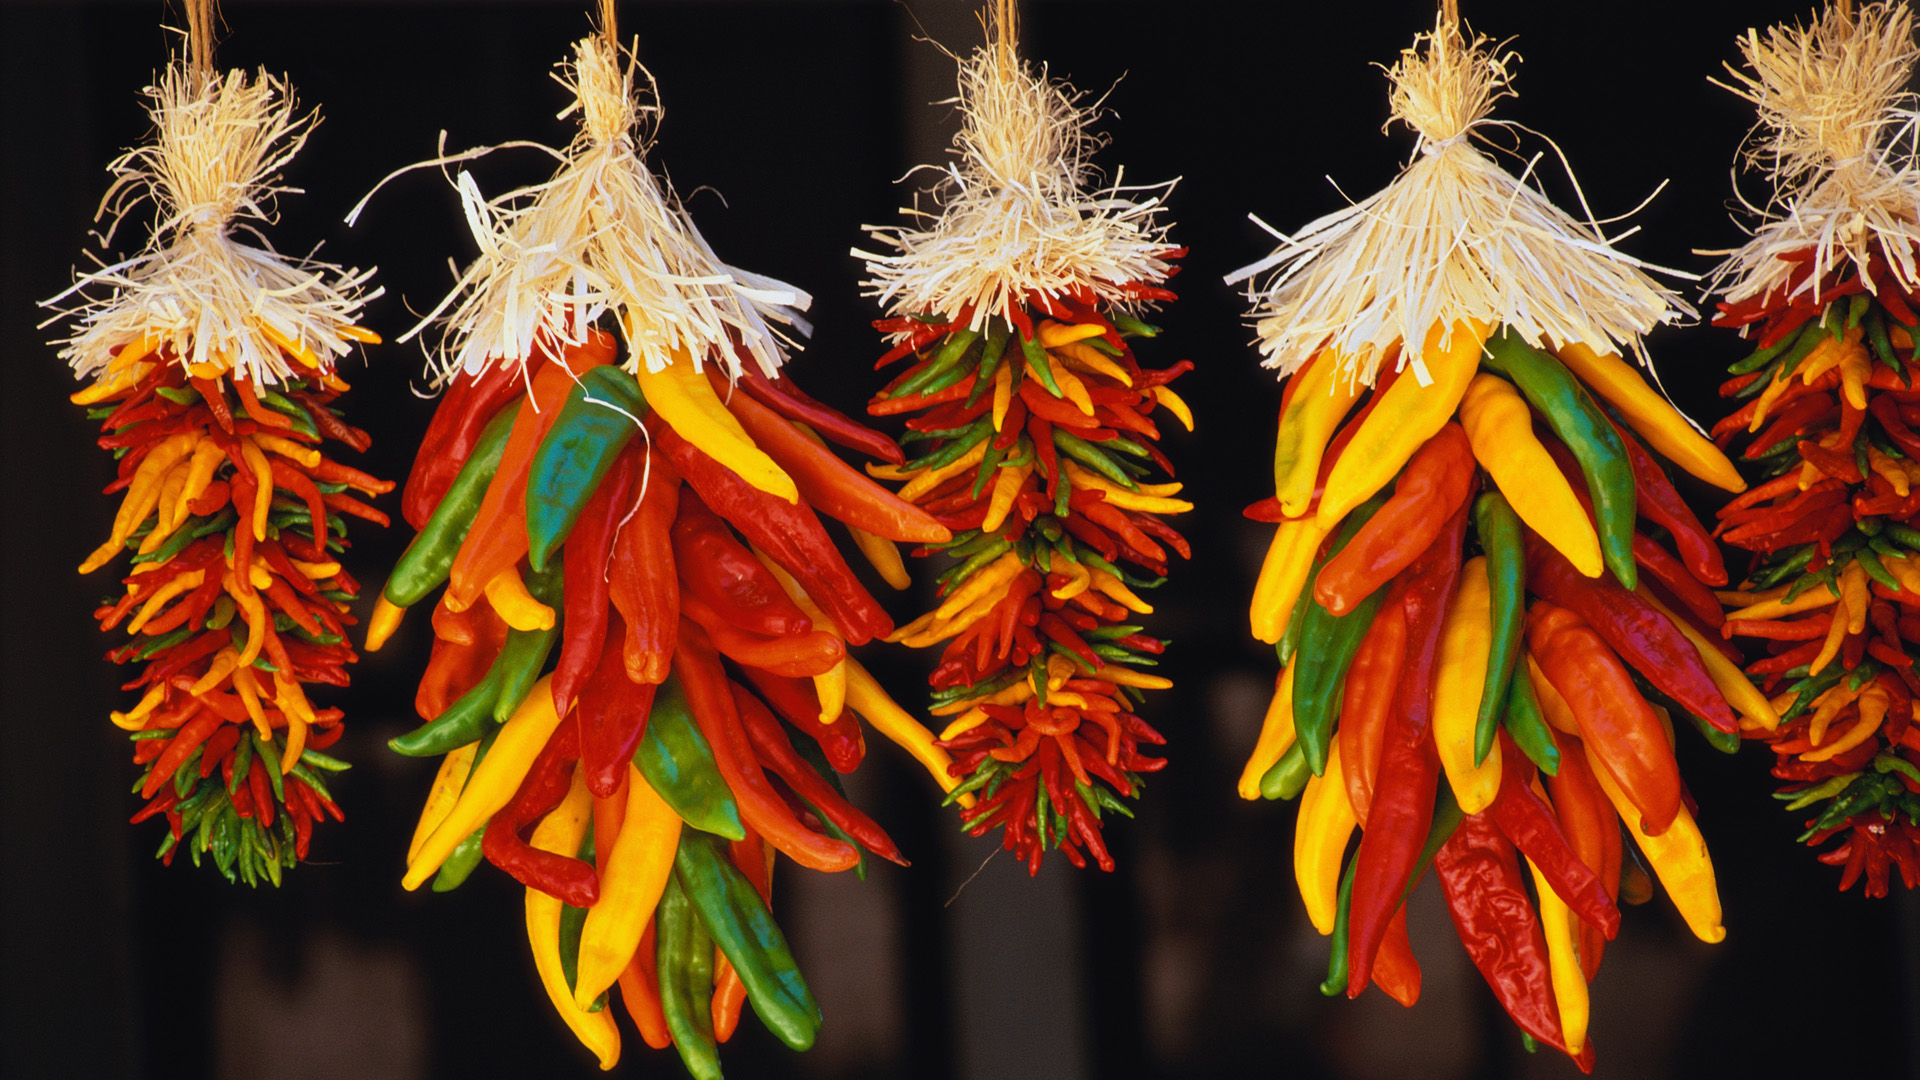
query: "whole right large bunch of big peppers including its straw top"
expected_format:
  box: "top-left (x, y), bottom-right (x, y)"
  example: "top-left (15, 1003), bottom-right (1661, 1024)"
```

top-left (1236, 21), bottom-right (1772, 1068)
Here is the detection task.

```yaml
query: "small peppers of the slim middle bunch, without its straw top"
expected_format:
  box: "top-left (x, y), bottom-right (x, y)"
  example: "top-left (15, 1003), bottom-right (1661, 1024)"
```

top-left (868, 274), bottom-right (1192, 872)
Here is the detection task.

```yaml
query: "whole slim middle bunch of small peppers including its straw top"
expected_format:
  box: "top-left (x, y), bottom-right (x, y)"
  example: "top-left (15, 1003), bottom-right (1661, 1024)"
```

top-left (854, 4), bottom-right (1192, 872)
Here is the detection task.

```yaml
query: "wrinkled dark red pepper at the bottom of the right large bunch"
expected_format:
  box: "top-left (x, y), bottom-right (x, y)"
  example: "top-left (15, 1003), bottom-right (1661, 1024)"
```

top-left (1436, 813), bottom-right (1594, 1070)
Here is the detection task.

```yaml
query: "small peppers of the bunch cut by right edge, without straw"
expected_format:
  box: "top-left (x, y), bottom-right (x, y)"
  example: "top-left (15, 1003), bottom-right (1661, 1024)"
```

top-left (1713, 248), bottom-right (1920, 896)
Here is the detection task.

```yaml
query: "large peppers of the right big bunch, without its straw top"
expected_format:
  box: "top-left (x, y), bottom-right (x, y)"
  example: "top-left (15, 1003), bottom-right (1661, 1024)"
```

top-left (1240, 321), bottom-right (1764, 1068)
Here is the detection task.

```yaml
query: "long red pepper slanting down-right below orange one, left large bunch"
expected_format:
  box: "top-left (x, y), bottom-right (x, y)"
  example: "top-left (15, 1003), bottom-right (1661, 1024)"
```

top-left (651, 423), bottom-right (893, 646)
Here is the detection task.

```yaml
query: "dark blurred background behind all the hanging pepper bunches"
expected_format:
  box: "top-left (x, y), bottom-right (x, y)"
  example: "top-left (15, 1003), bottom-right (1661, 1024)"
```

top-left (0, 0), bottom-right (1920, 1080)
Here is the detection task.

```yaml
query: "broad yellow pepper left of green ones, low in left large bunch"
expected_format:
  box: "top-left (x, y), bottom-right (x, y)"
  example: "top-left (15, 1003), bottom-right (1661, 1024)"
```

top-left (574, 765), bottom-right (680, 1009)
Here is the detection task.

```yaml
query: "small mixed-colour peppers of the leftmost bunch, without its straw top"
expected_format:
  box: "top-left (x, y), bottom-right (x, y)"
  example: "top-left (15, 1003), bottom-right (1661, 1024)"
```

top-left (73, 327), bottom-right (394, 886)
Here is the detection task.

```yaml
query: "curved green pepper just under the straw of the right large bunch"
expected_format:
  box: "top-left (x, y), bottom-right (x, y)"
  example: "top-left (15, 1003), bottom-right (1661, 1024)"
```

top-left (1482, 331), bottom-right (1640, 590)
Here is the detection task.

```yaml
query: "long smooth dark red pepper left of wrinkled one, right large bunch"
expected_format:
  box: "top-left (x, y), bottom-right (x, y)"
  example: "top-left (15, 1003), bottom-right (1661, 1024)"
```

top-left (1346, 699), bottom-right (1436, 997)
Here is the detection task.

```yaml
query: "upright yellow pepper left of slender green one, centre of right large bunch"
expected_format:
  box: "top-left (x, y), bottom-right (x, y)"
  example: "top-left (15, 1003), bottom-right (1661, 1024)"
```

top-left (1432, 555), bottom-right (1500, 813)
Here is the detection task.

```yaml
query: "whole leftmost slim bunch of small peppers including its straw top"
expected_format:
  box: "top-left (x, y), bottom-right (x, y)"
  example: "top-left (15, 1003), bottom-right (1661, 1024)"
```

top-left (48, 61), bottom-right (394, 884)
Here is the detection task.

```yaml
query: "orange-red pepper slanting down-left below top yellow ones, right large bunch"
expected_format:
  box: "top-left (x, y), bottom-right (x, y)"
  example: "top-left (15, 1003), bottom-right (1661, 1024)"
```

top-left (1313, 423), bottom-right (1476, 615)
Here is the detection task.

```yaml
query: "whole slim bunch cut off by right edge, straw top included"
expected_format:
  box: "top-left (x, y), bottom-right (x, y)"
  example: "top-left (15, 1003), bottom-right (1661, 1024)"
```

top-left (1713, 4), bottom-right (1920, 896)
